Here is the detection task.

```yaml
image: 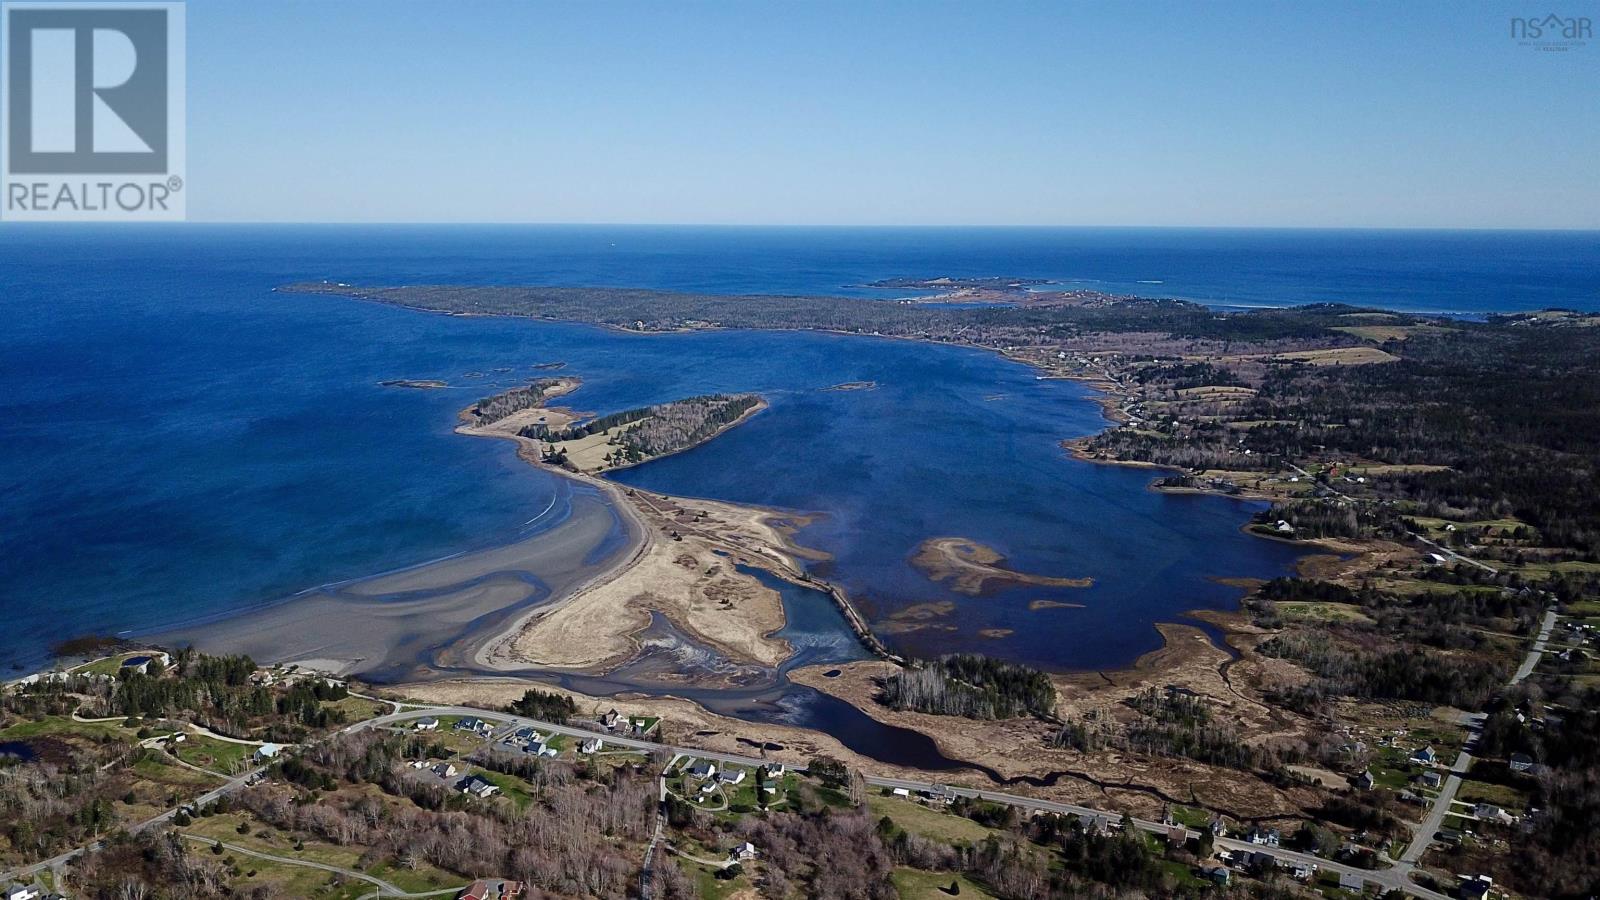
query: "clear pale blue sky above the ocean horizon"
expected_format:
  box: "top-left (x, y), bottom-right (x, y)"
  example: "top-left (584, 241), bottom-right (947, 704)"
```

top-left (189, 0), bottom-right (1600, 227)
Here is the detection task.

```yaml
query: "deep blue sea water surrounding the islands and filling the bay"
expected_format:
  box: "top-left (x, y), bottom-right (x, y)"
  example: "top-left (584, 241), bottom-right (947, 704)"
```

top-left (0, 226), bottom-right (1600, 668)
